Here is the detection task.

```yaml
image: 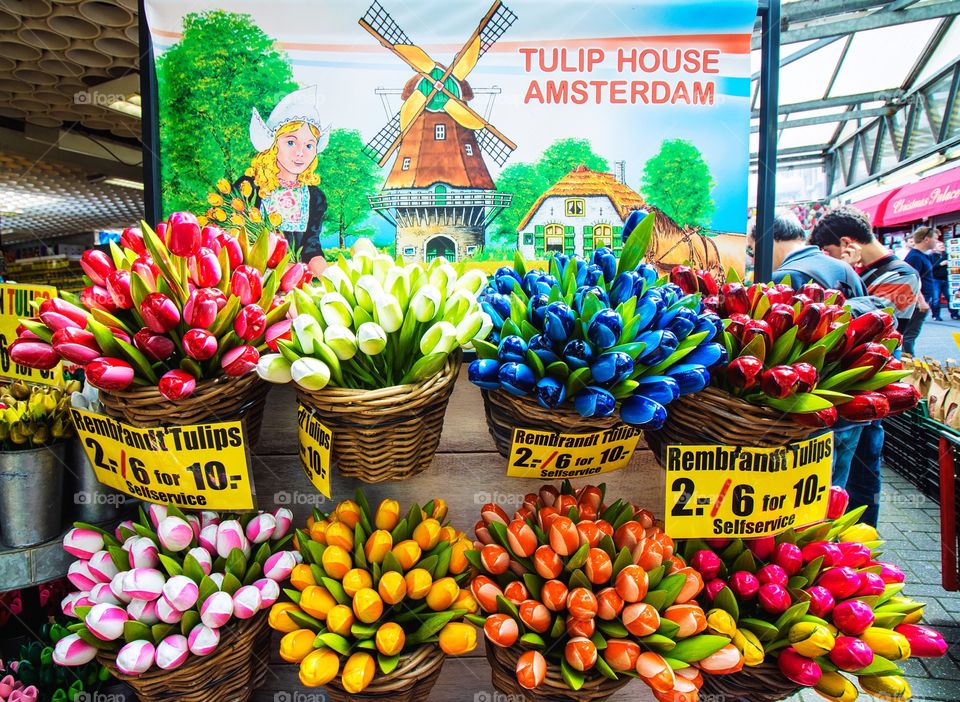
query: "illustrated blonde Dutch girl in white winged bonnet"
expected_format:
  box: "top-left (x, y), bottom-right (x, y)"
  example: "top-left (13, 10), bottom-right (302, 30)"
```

top-left (234, 85), bottom-right (330, 269)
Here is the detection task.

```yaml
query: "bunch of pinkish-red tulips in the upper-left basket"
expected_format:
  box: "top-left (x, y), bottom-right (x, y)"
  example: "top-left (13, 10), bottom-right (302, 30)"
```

top-left (10, 212), bottom-right (309, 402)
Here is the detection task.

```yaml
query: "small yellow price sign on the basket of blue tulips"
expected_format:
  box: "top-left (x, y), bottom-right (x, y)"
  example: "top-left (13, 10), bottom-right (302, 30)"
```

top-left (507, 426), bottom-right (640, 480)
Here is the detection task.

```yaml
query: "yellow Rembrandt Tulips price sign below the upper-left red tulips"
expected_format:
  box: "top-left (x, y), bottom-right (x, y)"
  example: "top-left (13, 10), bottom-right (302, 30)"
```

top-left (70, 409), bottom-right (256, 511)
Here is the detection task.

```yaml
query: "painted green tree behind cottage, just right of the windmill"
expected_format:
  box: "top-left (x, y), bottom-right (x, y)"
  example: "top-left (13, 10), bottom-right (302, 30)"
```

top-left (491, 138), bottom-right (610, 249)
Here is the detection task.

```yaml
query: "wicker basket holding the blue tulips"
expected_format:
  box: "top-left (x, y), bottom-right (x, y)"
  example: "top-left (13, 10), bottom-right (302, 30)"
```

top-left (481, 390), bottom-right (623, 458)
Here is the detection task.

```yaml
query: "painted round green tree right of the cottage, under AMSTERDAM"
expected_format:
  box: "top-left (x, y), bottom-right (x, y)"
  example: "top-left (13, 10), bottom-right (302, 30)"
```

top-left (640, 139), bottom-right (716, 227)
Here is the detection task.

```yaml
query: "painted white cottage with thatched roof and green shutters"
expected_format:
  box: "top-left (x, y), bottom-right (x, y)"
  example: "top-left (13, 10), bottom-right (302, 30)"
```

top-left (517, 166), bottom-right (644, 260)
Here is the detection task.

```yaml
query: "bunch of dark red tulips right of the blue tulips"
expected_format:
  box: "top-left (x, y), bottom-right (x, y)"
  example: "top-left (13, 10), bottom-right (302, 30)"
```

top-left (671, 266), bottom-right (919, 428)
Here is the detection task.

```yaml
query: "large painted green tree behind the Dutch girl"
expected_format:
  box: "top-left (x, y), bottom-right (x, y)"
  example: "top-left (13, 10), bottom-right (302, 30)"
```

top-left (157, 10), bottom-right (297, 213)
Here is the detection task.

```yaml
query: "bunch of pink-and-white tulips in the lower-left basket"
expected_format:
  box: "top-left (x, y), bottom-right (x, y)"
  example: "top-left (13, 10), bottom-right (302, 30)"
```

top-left (53, 505), bottom-right (299, 677)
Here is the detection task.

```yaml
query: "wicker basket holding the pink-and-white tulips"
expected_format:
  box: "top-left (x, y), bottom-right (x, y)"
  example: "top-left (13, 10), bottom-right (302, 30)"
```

top-left (97, 611), bottom-right (270, 702)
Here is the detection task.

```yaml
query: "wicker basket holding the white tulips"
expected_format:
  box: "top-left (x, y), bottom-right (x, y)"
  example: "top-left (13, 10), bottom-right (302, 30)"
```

top-left (298, 350), bottom-right (462, 483)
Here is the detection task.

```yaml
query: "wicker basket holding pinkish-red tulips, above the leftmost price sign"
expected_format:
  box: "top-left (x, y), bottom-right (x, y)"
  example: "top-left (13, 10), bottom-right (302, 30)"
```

top-left (100, 373), bottom-right (270, 444)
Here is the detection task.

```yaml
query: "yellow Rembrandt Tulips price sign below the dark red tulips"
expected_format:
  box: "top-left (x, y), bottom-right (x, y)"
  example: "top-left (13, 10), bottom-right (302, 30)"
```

top-left (664, 433), bottom-right (833, 539)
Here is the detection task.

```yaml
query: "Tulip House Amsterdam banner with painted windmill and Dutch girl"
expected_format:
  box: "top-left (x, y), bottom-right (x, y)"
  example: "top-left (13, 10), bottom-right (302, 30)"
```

top-left (145, 0), bottom-right (757, 273)
